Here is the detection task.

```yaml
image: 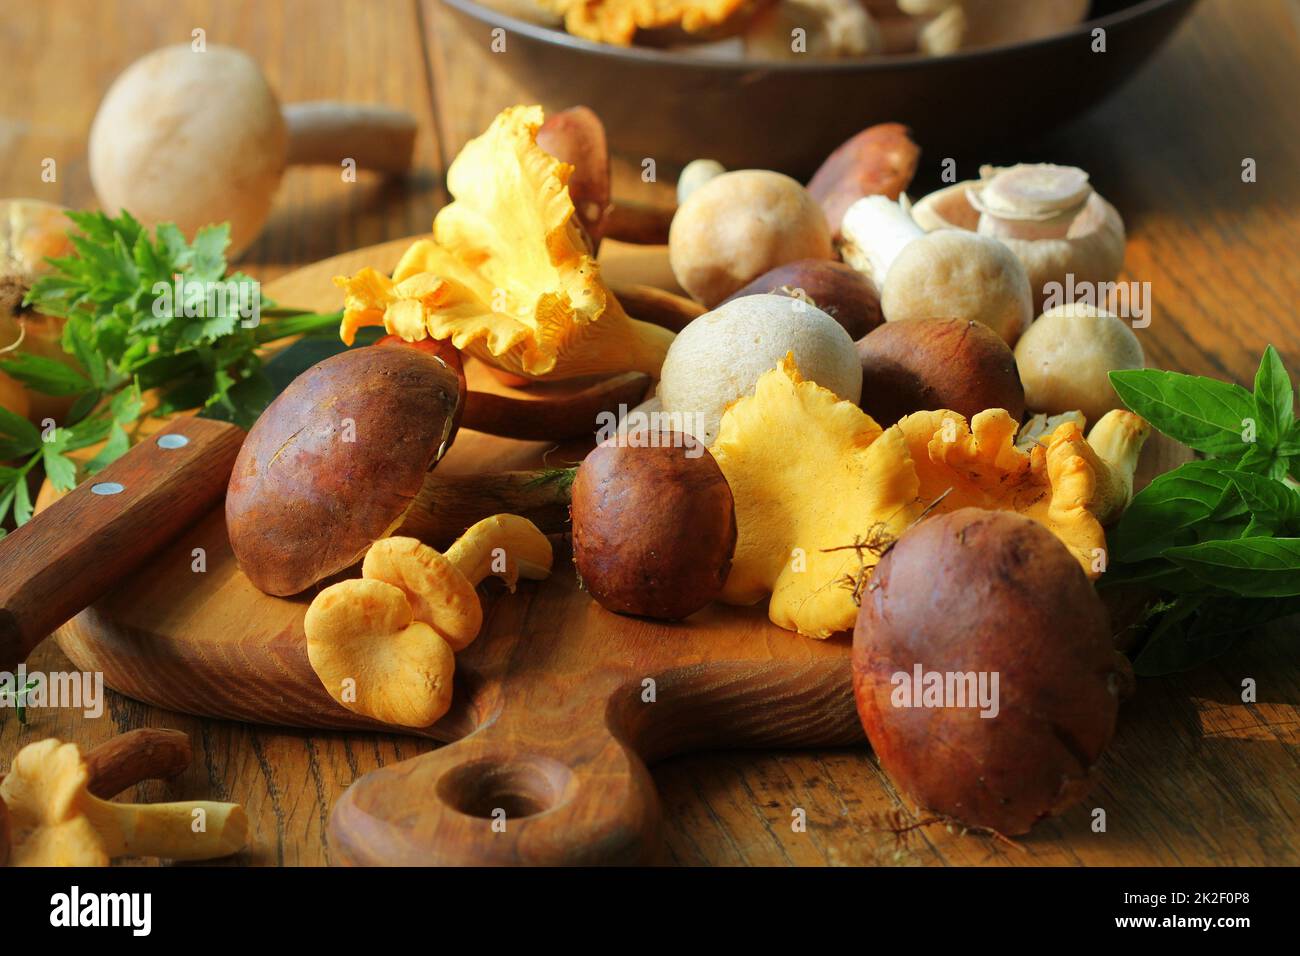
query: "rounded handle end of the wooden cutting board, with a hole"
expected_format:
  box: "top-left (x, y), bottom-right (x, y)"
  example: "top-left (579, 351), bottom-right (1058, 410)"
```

top-left (329, 701), bottom-right (662, 866)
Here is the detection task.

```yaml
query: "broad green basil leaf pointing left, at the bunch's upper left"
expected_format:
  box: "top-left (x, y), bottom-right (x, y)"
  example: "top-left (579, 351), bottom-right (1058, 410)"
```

top-left (1110, 368), bottom-right (1258, 458)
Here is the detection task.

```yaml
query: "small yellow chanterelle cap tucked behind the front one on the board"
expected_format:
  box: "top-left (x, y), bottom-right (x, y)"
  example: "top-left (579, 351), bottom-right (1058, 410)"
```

top-left (361, 537), bottom-right (484, 650)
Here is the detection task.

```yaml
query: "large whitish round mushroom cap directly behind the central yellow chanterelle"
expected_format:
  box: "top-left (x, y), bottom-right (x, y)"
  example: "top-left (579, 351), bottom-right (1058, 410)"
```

top-left (657, 294), bottom-right (862, 446)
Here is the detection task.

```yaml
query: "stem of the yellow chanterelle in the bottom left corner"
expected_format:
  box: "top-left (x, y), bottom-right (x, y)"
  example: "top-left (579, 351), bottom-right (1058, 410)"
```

top-left (86, 796), bottom-right (248, 860)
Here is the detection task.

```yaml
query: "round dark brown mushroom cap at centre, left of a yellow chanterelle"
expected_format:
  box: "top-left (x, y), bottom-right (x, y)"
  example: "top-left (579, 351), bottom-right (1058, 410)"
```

top-left (571, 429), bottom-right (736, 620)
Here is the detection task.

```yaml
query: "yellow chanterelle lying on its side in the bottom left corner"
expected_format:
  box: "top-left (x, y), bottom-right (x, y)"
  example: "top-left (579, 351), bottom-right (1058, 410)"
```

top-left (0, 739), bottom-right (248, 866)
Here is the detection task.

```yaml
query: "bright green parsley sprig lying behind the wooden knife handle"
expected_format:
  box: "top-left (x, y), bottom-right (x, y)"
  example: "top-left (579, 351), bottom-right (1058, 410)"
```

top-left (0, 212), bottom-right (339, 533)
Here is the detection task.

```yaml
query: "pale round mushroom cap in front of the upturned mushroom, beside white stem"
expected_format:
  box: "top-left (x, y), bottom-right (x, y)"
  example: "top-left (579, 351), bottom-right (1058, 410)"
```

top-left (880, 229), bottom-right (1034, 346)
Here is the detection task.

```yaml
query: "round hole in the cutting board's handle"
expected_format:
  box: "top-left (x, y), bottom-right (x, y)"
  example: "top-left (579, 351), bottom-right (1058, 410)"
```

top-left (437, 754), bottom-right (573, 821)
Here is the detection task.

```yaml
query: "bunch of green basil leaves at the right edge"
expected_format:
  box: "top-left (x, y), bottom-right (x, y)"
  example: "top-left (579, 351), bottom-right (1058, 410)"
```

top-left (1102, 346), bottom-right (1300, 675)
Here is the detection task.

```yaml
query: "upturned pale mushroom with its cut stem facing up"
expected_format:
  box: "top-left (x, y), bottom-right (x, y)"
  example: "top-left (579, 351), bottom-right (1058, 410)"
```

top-left (911, 164), bottom-right (1125, 313)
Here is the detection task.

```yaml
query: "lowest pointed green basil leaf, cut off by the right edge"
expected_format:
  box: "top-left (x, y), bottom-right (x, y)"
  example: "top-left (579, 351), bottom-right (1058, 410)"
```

top-left (1165, 537), bottom-right (1300, 597)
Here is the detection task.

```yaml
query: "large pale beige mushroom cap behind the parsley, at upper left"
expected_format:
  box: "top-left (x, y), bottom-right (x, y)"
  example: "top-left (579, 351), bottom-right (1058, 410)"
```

top-left (88, 43), bottom-right (287, 258)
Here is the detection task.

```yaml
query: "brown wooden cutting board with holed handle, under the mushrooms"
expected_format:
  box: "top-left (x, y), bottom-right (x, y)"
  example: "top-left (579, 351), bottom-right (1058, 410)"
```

top-left (48, 241), bottom-right (862, 864)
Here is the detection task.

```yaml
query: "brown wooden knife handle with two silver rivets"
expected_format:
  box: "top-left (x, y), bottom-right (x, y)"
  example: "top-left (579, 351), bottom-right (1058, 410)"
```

top-left (0, 416), bottom-right (244, 670)
